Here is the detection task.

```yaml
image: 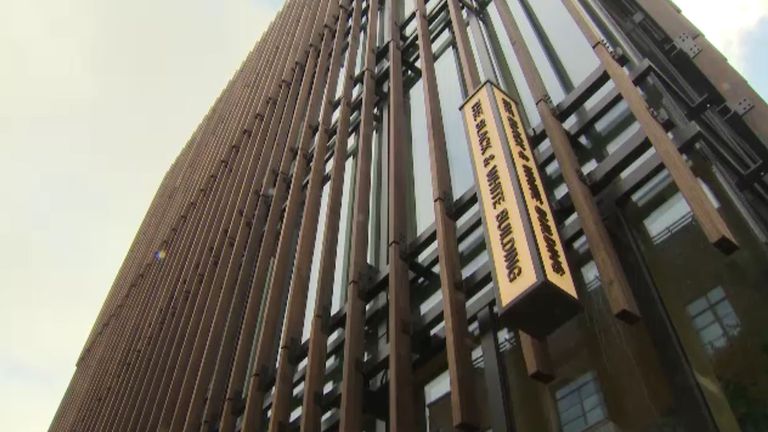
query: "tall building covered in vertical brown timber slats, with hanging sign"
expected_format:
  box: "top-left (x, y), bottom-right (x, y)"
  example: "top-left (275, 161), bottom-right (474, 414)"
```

top-left (51, 0), bottom-right (768, 432)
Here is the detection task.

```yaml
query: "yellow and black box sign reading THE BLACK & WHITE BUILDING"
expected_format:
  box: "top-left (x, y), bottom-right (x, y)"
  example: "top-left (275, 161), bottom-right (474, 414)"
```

top-left (462, 83), bottom-right (579, 336)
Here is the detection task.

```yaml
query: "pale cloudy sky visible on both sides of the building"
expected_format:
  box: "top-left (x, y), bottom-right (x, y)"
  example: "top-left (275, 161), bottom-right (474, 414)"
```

top-left (0, 0), bottom-right (768, 432)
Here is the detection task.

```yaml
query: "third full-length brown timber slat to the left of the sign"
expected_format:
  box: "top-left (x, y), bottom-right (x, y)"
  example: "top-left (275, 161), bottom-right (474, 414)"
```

top-left (340, 0), bottom-right (379, 432)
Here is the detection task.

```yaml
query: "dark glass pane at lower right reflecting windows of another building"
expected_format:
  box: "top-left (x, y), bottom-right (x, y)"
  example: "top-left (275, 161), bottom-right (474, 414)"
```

top-left (622, 149), bottom-right (768, 431)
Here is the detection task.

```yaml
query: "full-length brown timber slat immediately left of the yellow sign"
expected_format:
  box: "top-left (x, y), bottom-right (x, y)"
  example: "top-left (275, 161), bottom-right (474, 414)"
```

top-left (416, 0), bottom-right (478, 428)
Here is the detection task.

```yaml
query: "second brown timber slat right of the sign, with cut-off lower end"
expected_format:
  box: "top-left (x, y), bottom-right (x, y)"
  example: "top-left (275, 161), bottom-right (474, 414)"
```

top-left (562, 0), bottom-right (738, 254)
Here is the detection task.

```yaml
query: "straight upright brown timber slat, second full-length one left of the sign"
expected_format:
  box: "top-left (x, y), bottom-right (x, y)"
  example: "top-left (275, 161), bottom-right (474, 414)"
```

top-left (388, 0), bottom-right (415, 432)
